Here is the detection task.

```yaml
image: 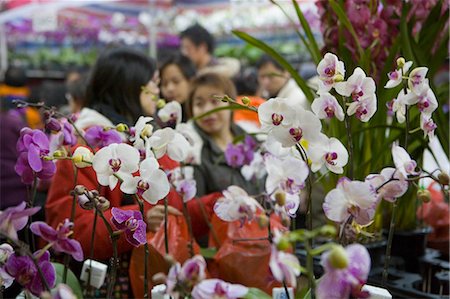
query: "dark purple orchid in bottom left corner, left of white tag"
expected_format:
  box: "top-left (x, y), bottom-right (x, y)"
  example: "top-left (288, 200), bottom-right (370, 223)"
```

top-left (5, 251), bottom-right (56, 296)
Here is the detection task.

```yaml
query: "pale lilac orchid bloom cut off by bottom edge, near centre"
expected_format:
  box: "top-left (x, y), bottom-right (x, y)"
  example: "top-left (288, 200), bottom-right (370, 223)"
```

top-left (192, 279), bottom-right (248, 299)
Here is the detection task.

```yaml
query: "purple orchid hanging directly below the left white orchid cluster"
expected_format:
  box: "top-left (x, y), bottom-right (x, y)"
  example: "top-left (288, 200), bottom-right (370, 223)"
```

top-left (111, 208), bottom-right (147, 247)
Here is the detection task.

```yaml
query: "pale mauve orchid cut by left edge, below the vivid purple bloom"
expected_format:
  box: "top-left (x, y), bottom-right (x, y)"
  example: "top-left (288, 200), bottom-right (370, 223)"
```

top-left (0, 201), bottom-right (41, 240)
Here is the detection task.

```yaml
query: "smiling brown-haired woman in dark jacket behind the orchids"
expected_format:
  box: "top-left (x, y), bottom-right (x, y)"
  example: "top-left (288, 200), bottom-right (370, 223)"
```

top-left (187, 73), bottom-right (263, 196)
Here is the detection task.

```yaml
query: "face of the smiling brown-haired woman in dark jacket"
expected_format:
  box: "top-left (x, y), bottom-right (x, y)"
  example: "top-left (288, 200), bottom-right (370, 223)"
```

top-left (192, 85), bottom-right (231, 135)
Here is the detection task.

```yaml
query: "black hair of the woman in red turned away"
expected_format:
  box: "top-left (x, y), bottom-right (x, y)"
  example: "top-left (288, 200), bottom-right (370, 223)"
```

top-left (86, 48), bottom-right (156, 122)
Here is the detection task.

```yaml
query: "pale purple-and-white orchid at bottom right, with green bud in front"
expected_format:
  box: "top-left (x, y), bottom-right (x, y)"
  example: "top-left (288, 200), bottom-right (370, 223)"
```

top-left (316, 244), bottom-right (370, 299)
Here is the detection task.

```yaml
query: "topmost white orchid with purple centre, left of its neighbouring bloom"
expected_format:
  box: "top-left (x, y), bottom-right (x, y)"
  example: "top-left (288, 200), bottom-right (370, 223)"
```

top-left (317, 53), bottom-right (345, 91)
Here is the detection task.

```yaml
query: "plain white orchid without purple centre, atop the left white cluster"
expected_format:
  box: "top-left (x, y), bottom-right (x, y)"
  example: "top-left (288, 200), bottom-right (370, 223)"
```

top-left (148, 128), bottom-right (190, 162)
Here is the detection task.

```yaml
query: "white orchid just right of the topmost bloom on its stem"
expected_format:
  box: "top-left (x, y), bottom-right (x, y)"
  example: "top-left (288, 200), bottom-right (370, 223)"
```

top-left (334, 67), bottom-right (376, 101)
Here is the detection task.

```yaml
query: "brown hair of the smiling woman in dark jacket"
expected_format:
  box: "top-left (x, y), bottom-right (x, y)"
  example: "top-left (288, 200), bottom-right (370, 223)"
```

top-left (187, 73), bottom-right (236, 118)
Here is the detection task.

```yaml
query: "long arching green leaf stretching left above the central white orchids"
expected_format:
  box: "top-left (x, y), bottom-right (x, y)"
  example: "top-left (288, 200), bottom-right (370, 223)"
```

top-left (232, 30), bottom-right (314, 102)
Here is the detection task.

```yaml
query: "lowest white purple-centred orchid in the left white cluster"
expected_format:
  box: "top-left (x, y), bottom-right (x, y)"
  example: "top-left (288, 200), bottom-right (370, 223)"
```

top-left (120, 157), bottom-right (170, 204)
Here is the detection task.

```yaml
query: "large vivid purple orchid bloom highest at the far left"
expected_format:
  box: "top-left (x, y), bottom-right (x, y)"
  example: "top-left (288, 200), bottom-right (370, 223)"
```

top-left (15, 128), bottom-right (56, 185)
